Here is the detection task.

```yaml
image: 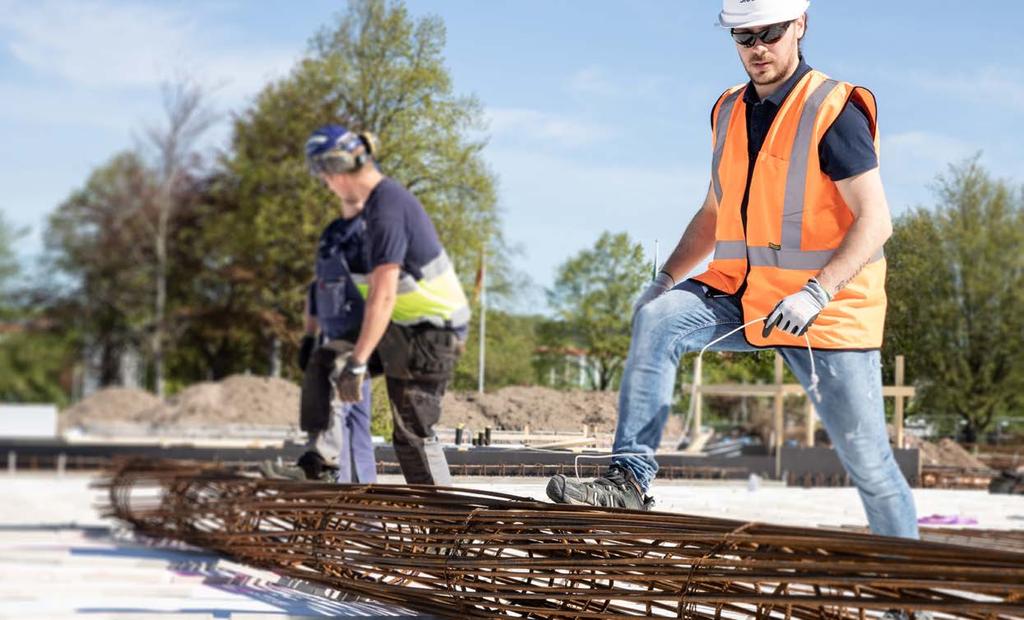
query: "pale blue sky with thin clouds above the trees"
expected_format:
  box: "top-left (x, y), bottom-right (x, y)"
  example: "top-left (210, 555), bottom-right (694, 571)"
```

top-left (0, 0), bottom-right (1024, 309)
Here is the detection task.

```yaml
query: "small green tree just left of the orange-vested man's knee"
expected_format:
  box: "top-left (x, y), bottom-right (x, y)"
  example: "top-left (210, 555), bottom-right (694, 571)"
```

top-left (542, 233), bottom-right (650, 389)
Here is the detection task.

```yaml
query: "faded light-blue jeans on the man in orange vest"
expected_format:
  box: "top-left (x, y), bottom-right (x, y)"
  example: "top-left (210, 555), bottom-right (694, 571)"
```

top-left (612, 280), bottom-right (918, 538)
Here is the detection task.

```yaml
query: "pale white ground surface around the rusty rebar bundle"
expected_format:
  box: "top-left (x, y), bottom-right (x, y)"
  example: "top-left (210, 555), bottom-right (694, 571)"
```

top-left (0, 472), bottom-right (1024, 619)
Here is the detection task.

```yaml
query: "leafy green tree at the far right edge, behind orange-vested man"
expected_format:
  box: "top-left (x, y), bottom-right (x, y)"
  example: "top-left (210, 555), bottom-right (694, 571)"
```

top-left (886, 158), bottom-right (1024, 440)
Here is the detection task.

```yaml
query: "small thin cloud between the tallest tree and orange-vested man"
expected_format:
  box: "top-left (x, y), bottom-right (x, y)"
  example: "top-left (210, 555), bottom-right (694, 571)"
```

top-left (486, 108), bottom-right (615, 148)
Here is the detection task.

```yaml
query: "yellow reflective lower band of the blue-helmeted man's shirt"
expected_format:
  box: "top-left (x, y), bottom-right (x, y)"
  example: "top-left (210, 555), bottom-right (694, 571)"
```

top-left (353, 250), bottom-right (470, 328)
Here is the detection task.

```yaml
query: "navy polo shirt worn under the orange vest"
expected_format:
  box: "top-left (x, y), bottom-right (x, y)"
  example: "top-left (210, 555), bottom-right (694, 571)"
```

top-left (712, 60), bottom-right (879, 181)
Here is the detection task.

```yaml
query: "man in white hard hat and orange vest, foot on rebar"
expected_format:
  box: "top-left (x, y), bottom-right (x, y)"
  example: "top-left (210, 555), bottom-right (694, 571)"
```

top-left (548, 0), bottom-right (918, 538)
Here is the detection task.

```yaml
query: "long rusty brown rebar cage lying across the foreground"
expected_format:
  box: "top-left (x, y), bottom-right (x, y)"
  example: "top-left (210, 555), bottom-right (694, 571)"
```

top-left (100, 460), bottom-right (1024, 619)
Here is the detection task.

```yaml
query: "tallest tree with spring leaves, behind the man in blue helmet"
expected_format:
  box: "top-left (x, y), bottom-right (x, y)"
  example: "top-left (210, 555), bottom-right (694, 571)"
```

top-left (216, 0), bottom-right (503, 377)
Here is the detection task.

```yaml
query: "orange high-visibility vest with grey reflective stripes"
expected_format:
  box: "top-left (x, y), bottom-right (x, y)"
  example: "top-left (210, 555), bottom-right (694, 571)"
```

top-left (696, 71), bottom-right (886, 348)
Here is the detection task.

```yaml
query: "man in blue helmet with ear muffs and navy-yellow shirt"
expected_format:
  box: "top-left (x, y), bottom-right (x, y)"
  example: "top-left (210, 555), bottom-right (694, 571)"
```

top-left (306, 125), bottom-right (469, 485)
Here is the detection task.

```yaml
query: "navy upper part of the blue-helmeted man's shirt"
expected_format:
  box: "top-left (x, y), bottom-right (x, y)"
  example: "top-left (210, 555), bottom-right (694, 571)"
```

top-left (362, 177), bottom-right (443, 280)
